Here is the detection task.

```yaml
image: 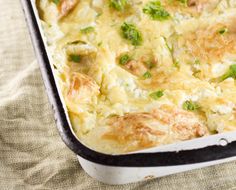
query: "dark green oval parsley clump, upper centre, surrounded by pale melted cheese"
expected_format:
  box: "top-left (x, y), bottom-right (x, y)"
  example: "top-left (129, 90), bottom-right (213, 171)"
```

top-left (121, 22), bottom-right (143, 46)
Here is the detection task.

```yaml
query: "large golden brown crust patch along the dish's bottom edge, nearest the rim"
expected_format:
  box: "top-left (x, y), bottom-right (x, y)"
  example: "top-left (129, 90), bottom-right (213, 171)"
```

top-left (102, 105), bottom-right (208, 151)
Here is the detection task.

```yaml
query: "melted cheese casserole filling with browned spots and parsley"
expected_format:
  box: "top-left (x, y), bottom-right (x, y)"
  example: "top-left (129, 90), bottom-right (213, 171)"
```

top-left (37, 0), bottom-right (236, 154)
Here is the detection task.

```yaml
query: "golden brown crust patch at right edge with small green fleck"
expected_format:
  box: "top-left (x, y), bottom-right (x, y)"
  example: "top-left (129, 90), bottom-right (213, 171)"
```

top-left (184, 24), bottom-right (236, 63)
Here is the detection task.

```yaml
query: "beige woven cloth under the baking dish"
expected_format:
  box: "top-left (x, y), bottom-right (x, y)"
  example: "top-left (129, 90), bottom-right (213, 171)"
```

top-left (0, 0), bottom-right (236, 190)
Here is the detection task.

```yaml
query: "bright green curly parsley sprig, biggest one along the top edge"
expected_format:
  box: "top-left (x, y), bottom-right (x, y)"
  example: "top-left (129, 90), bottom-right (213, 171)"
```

top-left (143, 1), bottom-right (170, 21)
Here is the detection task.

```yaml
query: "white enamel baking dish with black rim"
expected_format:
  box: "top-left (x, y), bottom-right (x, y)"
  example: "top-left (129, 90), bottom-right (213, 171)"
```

top-left (21, 0), bottom-right (236, 184)
